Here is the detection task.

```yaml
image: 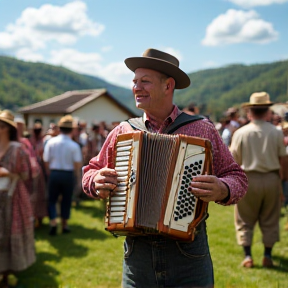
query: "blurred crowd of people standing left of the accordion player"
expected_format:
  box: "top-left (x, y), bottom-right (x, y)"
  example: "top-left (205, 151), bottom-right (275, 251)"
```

top-left (0, 110), bottom-right (116, 287)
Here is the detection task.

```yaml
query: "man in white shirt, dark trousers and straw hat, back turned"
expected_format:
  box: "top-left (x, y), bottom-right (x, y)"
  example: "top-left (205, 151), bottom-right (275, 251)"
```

top-left (43, 115), bottom-right (82, 236)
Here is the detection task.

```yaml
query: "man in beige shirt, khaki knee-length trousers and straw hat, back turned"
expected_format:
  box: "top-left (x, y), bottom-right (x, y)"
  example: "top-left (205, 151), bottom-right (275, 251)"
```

top-left (230, 92), bottom-right (287, 268)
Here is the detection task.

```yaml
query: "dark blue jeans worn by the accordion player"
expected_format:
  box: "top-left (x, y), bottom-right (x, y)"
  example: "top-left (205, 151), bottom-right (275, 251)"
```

top-left (122, 222), bottom-right (214, 288)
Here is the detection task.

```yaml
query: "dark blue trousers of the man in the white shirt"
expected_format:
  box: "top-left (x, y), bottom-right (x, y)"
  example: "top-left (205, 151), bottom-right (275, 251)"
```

top-left (48, 170), bottom-right (74, 220)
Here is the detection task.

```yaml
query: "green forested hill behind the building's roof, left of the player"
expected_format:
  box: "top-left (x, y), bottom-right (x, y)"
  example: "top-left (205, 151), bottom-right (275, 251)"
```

top-left (0, 56), bottom-right (139, 111)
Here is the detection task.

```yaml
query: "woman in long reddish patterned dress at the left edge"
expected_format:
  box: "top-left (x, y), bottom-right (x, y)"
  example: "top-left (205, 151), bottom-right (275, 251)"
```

top-left (0, 110), bottom-right (36, 287)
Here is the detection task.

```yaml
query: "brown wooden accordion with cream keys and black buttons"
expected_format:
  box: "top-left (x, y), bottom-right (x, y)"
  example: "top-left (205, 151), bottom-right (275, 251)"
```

top-left (105, 131), bottom-right (212, 241)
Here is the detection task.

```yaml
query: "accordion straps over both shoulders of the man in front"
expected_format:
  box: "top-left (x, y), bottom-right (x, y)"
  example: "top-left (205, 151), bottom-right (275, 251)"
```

top-left (127, 112), bottom-right (205, 134)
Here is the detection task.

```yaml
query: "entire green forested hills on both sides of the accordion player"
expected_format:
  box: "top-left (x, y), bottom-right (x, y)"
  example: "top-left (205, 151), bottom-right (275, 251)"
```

top-left (0, 56), bottom-right (288, 118)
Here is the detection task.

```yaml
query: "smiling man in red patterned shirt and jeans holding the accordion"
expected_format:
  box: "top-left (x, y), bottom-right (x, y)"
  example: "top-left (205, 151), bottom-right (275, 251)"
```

top-left (82, 48), bottom-right (247, 287)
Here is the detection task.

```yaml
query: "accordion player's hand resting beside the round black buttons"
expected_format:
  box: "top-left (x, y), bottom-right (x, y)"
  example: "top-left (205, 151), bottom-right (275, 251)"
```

top-left (189, 175), bottom-right (229, 202)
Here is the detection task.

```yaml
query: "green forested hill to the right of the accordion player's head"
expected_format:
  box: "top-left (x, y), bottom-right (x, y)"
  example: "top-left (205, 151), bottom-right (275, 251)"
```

top-left (175, 60), bottom-right (288, 117)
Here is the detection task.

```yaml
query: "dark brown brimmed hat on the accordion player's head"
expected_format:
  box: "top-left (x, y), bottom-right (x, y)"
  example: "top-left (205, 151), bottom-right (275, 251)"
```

top-left (125, 48), bottom-right (190, 89)
